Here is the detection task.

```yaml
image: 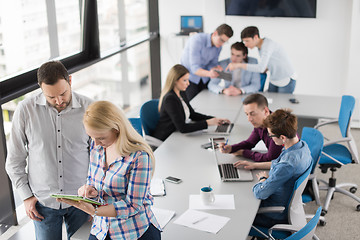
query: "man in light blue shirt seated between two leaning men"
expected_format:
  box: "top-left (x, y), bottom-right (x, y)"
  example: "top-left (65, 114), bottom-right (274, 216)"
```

top-left (208, 42), bottom-right (260, 96)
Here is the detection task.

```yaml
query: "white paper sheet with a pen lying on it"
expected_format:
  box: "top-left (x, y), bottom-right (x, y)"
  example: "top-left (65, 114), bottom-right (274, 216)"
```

top-left (174, 209), bottom-right (230, 234)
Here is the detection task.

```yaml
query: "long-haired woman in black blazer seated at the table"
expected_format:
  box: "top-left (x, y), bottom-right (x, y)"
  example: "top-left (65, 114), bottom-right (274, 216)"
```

top-left (152, 64), bottom-right (229, 141)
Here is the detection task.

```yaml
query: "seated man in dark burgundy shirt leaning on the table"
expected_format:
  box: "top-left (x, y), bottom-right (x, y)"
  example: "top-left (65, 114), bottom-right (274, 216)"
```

top-left (220, 93), bottom-right (282, 162)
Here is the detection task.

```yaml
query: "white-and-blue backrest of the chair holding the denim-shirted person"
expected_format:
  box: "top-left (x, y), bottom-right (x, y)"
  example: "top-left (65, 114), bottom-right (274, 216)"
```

top-left (287, 165), bottom-right (312, 228)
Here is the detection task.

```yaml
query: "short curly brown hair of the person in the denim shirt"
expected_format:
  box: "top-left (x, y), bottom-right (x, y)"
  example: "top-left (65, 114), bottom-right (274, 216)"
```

top-left (264, 109), bottom-right (298, 138)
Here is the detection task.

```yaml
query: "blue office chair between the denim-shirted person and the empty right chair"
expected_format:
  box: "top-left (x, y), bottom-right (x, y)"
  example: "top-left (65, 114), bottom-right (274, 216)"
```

top-left (301, 127), bottom-right (326, 226)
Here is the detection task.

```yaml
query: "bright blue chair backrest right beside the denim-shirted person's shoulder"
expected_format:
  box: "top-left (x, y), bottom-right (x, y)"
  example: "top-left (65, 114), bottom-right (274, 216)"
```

top-left (301, 127), bottom-right (324, 173)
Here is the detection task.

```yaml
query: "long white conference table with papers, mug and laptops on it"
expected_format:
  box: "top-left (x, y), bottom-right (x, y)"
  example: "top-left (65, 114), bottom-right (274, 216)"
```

top-left (154, 90), bottom-right (354, 240)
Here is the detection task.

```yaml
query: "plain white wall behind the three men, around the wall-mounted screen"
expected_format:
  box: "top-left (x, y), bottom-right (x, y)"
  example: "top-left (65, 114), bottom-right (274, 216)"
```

top-left (159, 0), bottom-right (360, 96)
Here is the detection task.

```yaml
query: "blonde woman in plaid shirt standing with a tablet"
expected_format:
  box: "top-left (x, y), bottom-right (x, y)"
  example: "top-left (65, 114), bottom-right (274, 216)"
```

top-left (60, 101), bottom-right (161, 240)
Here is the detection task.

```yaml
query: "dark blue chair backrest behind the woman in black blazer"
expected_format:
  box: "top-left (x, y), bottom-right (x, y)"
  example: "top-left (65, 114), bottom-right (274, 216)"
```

top-left (140, 99), bottom-right (160, 136)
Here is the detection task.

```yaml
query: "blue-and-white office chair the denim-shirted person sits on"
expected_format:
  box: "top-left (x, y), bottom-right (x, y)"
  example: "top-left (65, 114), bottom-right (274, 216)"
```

top-left (249, 166), bottom-right (312, 239)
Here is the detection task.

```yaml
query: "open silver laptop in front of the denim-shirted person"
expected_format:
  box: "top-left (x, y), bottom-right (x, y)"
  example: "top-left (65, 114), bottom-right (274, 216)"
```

top-left (211, 138), bottom-right (254, 182)
